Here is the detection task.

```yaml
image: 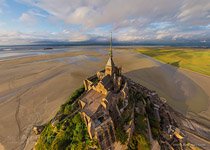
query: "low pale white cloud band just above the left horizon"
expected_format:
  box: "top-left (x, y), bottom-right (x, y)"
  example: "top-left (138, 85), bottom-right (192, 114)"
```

top-left (0, 29), bottom-right (92, 45)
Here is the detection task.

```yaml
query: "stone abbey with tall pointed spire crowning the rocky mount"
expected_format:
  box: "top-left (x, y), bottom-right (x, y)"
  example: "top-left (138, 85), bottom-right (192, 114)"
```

top-left (79, 35), bottom-right (129, 149)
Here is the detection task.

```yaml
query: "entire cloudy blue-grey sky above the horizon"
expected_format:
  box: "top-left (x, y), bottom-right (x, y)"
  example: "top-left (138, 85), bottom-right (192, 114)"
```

top-left (0, 0), bottom-right (210, 45)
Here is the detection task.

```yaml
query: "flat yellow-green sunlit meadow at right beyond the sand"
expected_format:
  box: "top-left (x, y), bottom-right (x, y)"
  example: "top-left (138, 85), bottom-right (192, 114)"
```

top-left (137, 47), bottom-right (210, 76)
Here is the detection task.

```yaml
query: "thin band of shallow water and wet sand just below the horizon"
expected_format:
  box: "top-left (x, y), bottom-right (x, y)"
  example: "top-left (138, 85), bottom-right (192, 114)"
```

top-left (0, 45), bottom-right (208, 61)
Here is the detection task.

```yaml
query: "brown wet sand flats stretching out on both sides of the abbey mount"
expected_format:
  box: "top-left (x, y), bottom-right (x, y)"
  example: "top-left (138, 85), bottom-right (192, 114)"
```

top-left (0, 47), bottom-right (210, 149)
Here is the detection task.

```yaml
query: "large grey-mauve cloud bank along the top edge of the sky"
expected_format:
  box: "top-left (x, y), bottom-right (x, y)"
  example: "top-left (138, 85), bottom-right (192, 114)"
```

top-left (20, 0), bottom-right (210, 27)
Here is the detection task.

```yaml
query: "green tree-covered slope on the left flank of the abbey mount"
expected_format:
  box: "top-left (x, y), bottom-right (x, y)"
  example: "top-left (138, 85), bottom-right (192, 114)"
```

top-left (35, 87), bottom-right (97, 150)
